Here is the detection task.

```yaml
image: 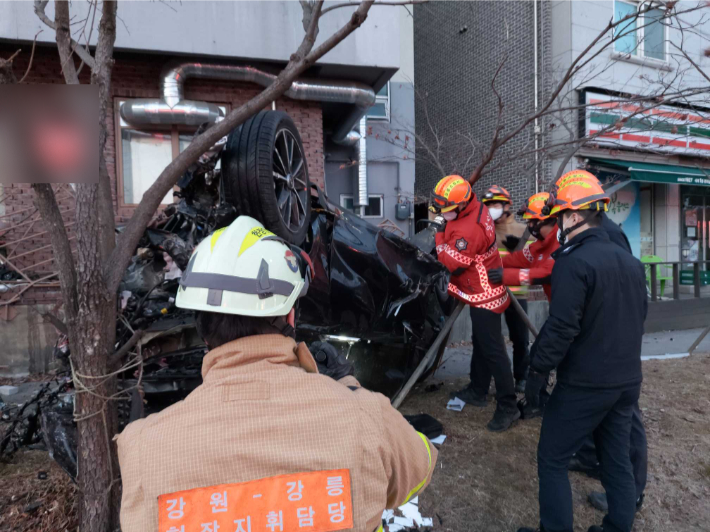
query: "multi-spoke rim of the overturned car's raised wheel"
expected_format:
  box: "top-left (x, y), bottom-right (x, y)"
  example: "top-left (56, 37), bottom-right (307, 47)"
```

top-left (272, 129), bottom-right (308, 233)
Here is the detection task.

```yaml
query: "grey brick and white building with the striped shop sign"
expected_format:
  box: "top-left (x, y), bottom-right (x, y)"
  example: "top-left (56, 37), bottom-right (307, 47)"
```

top-left (414, 0), bottom-right (710, 276)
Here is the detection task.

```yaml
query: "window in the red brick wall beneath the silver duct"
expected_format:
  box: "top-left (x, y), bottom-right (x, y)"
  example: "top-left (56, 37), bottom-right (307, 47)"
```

top-left (116, 101), bottom-right (227, 205)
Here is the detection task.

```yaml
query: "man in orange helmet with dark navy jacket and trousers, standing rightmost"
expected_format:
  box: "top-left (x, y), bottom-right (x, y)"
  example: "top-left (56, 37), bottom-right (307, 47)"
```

top-left (519, 170), bottom-right (647, 532)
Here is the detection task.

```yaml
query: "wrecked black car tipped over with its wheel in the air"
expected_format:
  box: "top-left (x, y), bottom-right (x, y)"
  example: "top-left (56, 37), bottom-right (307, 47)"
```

top-left (42, 111), bottom-right (452, 480)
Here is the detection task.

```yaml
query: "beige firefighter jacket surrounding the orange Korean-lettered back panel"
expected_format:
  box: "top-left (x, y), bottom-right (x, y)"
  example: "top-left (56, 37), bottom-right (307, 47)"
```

top-left (116, 335), bottom-right (437, 532)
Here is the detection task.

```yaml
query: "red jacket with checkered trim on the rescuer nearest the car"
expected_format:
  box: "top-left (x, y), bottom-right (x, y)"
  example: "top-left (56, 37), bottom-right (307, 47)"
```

top-left (436, 195), bottom-right (510, 314)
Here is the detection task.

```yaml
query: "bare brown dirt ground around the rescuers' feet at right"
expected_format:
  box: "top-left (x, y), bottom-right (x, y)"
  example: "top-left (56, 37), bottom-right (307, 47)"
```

top-left (401, 354), bottom-right (710, 532)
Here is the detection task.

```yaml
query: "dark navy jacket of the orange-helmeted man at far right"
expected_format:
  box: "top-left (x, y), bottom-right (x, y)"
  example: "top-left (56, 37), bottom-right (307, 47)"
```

top-left (530, 227), bottom-right (648, 388)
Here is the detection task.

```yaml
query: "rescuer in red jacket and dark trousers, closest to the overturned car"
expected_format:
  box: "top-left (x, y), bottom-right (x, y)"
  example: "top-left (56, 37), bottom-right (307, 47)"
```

top-left (431, 175), bottom-right (520, 432)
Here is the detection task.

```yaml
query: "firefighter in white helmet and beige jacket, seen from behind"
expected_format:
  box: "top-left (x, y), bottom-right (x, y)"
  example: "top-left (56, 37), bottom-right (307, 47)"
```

top-left (117, 216), bottom-right (437, 532)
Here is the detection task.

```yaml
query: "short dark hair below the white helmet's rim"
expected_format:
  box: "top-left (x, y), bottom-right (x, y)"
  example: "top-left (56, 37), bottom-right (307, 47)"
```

top-left (195, 311), bottom-right (281, 349)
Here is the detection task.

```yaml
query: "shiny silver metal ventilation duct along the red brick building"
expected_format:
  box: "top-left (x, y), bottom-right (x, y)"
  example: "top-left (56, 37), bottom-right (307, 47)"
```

top-left (121, 62), bottom-right (375, 146)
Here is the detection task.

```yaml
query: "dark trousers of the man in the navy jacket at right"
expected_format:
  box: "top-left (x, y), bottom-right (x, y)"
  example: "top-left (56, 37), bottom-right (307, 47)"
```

top-left (537, 383), bottom-right (641, 532)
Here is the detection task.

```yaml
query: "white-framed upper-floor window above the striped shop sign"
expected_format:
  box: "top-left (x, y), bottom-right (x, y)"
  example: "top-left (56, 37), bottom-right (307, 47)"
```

top-left (614, 0), bottom-right (666, 61)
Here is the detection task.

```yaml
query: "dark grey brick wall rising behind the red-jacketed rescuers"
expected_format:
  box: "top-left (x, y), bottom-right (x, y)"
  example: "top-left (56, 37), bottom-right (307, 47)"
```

top-left (414, 0), bottom-right (550, 208)
